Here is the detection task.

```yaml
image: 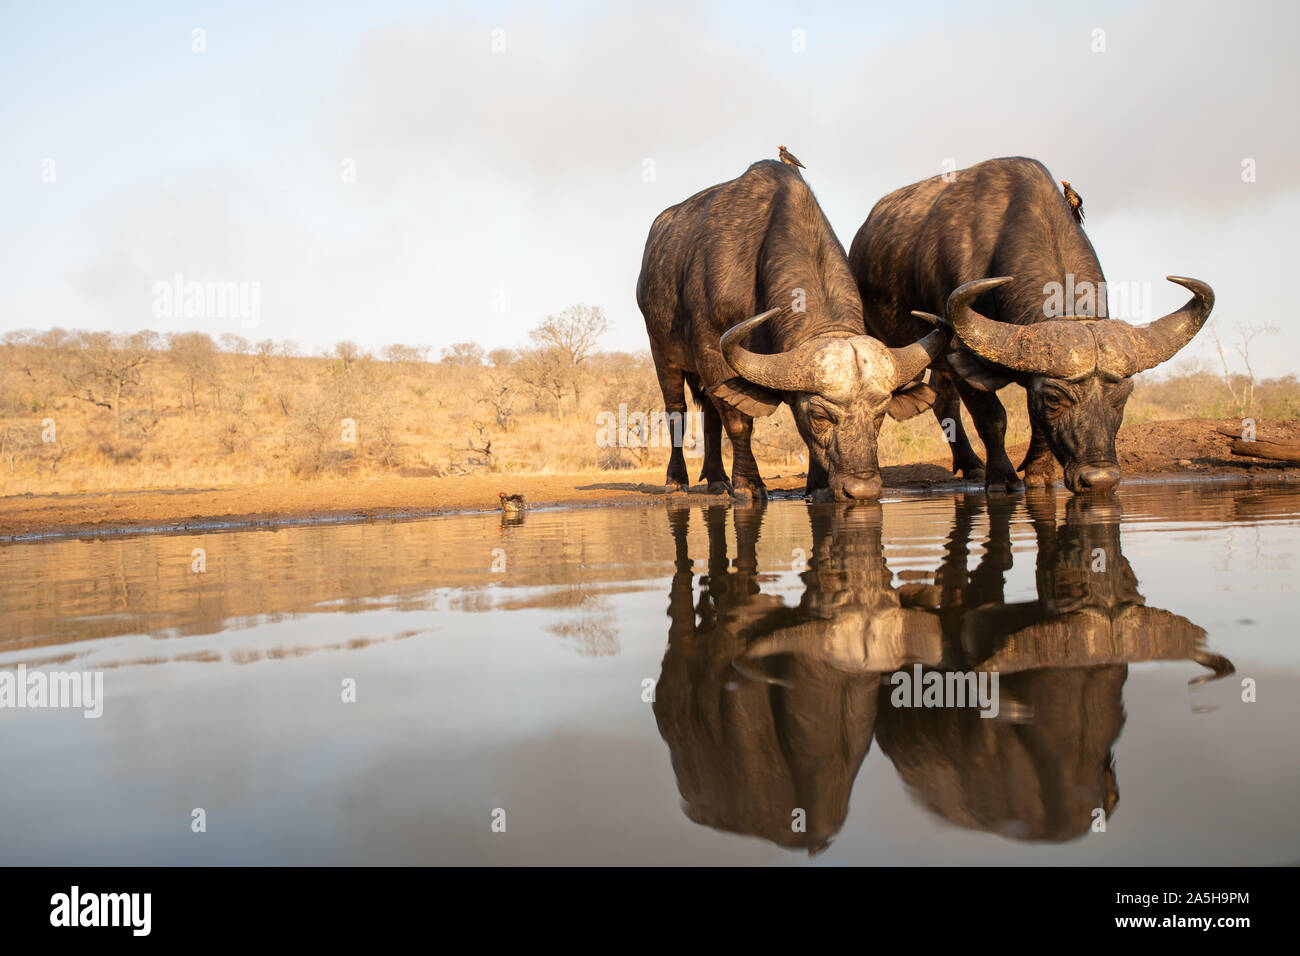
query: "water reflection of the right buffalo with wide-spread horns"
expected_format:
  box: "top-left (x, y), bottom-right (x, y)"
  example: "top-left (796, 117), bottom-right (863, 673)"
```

top-left (876, 494), bottom-right (1234, 842)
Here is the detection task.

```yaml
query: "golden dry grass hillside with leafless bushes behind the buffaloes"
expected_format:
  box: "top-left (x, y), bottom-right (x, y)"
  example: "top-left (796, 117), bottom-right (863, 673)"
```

top-left (0, 330), bottom-right (1300, 494)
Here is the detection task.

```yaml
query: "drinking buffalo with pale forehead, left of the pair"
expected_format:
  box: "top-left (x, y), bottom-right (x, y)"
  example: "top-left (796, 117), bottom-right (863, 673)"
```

top-left (637, 160), bottom-right (946, 499)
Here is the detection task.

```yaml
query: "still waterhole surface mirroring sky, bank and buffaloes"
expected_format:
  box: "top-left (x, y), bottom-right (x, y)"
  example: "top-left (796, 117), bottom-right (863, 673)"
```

top-left (0, 484), bottom-right (1300, 865)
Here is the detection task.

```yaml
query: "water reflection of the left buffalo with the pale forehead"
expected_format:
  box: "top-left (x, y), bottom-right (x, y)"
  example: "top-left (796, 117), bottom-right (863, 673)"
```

top-left (654, 502), bottom-right (920, 855)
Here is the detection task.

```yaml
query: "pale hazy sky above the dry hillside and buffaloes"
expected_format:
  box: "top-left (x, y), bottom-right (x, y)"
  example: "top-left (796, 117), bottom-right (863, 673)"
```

top-left (0, 0), bottom-right (1300, 376)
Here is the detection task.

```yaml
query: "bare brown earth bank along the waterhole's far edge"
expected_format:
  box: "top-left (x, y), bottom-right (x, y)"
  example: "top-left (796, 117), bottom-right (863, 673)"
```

top-left (0, 420), bottom-right (1300, 541)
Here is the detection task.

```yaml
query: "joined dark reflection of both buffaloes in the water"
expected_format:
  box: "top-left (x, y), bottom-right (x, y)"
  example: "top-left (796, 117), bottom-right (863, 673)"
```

top-left (654, 494), bottom-right (1232, 853)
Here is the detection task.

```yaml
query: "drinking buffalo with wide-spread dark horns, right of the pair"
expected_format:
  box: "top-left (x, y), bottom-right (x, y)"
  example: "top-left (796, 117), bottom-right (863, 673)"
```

top-left (849, 157), bottom-right (1214, 493)
